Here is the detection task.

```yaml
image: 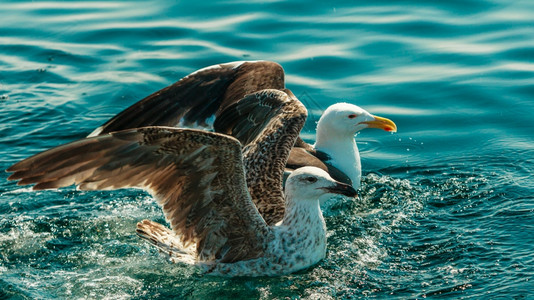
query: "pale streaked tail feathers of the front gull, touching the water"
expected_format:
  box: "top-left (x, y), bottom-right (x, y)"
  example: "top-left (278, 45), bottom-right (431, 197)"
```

top-left (136, 220), bottom-right (196, 264)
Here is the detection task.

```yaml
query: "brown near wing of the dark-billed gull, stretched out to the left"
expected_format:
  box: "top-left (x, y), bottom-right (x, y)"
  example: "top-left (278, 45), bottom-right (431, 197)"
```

top-left (7, 127), bottom-right (271, 262)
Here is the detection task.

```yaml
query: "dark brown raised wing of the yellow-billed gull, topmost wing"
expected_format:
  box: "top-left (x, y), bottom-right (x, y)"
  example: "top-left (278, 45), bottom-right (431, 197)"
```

top-left (89, 61), bottom-right (284, 136)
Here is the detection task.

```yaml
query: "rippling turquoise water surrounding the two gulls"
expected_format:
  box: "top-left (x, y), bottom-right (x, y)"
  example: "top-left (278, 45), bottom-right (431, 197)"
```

top-left (0, 0), bottom-right (534, 299)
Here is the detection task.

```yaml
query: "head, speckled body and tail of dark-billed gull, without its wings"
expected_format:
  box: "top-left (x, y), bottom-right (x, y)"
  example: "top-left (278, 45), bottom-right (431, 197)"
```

top-left (137, 167), bottom-right (356, 277)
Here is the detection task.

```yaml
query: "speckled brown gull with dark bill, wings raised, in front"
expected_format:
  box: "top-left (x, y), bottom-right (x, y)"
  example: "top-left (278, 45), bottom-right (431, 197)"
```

top-left (6, 90), bottom-right (357, 276)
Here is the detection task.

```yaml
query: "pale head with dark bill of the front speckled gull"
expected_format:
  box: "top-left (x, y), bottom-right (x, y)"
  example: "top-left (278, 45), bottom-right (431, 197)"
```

top-left (285, 167), bottom-right (357, 200)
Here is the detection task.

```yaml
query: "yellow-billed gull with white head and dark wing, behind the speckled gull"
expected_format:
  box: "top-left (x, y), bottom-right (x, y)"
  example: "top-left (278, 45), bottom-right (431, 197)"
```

top-left (89, 61), bottom-right (397, 189)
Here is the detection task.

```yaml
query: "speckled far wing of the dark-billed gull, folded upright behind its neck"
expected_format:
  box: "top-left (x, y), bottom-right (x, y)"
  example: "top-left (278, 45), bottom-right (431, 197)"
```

top-left (218, 89), bottom-right (308, 225)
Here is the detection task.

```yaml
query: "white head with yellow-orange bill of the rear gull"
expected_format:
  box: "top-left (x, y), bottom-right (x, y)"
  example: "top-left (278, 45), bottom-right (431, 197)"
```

top-left (317, 103), bottom-right (397, 138)
